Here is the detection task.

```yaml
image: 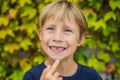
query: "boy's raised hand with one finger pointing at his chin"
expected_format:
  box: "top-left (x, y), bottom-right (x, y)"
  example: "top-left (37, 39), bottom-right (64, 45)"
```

top-left (40, 60), bottom-right (63, 80)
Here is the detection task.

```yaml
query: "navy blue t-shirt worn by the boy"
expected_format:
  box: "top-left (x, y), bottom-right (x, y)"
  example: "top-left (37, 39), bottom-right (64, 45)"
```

top-left (23, 62), bottom-right (102, 80)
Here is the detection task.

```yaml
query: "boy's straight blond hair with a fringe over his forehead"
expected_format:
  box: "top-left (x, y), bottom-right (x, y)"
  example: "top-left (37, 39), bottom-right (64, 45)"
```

top-left (39, 0), bottom-right (88, 37)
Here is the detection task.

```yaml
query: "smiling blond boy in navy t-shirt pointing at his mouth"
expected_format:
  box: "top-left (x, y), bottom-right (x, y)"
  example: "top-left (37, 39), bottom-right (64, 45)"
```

top-left (23, 0), bottom-right (101, 80)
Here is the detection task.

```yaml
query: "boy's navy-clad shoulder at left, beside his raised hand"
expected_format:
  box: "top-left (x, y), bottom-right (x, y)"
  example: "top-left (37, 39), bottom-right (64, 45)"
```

top-left (23, 63), bottom-right (45, 80)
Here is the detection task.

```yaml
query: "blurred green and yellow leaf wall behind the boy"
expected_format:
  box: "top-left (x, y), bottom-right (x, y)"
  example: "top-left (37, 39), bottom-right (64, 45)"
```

top-left (0, 0), bottom-right (120, 80)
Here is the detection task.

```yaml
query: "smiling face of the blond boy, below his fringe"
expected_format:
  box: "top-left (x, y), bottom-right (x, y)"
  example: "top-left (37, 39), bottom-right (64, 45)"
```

top-left (39, 17), bottom-right (81, 60)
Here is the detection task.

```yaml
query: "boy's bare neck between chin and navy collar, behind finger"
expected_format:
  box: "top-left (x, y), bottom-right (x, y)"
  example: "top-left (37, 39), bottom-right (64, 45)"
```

top-left (45, 58), bottom-right (78, 76)
